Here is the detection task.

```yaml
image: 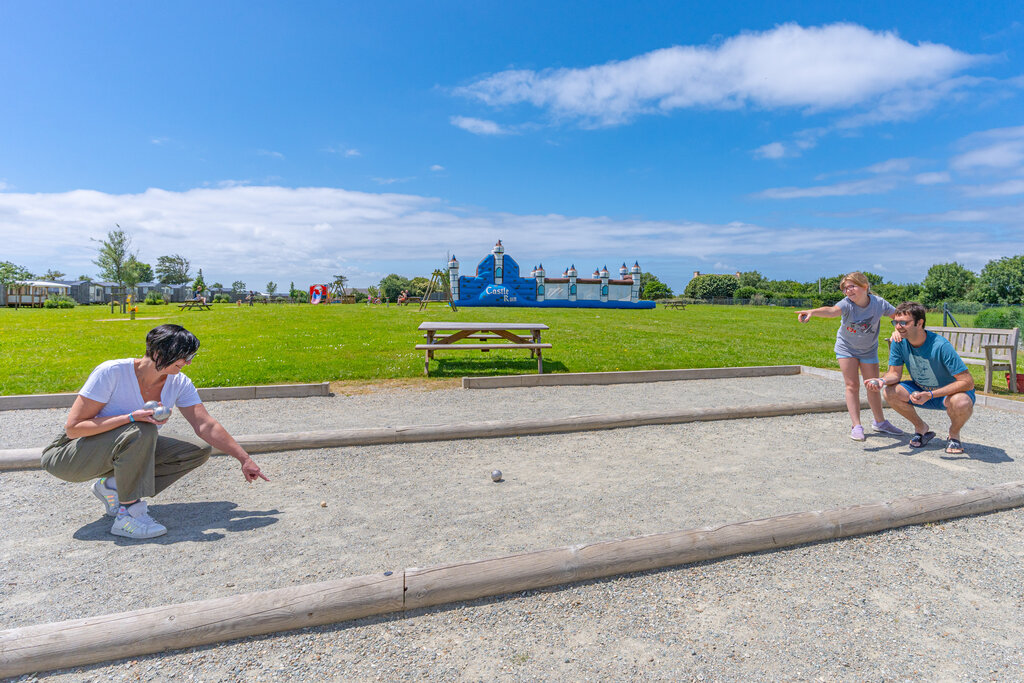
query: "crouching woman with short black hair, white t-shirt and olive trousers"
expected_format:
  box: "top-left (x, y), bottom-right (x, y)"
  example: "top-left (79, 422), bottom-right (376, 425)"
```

top-left (42, 325), bottom-right (269, 539)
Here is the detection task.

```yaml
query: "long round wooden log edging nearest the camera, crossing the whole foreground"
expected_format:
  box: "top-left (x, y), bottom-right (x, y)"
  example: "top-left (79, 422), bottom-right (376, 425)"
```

top-left (0, 481), bottom-right (1024, 677)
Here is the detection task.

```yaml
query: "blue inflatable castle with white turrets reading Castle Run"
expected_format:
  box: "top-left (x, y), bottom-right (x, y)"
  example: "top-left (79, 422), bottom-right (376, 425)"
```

top-left (449, 240), bottom-right (654, 308)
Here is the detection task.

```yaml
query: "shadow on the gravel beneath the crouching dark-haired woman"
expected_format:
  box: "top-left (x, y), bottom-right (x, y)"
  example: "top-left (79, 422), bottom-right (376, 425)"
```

top-left (74, 501), bottom-right (281, 546)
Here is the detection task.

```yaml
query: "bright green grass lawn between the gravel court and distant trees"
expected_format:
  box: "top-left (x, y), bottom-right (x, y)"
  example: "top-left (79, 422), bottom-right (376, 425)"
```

top-left (0, 304), bottom-right (1019, 395)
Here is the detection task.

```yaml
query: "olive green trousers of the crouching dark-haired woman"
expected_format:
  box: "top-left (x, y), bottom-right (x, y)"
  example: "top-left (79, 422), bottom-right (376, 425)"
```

top-left (41, 422), bottom-right (212, 501)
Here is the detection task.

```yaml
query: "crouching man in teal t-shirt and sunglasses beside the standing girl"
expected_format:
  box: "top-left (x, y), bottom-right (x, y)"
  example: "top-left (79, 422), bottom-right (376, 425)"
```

top-left (864, 301), bottom-right (975, 454)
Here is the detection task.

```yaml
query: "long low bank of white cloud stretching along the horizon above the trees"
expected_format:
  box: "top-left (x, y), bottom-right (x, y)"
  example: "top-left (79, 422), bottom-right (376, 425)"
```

top-left (0, 186), bottom-right (1024, 288)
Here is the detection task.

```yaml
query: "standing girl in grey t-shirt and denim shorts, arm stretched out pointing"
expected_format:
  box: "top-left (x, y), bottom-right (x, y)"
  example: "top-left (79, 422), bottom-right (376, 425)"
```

top-left (797, 272), bottom-right (903, 441)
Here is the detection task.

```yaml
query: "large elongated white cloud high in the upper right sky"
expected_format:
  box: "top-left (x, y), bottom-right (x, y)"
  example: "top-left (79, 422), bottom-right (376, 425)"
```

top-left (456, 24), bottom-right (986, 125)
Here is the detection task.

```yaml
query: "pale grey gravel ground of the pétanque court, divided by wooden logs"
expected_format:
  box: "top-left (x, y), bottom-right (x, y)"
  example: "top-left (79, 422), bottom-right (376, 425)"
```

top-left (0, 375), bottom-right (1024, 681)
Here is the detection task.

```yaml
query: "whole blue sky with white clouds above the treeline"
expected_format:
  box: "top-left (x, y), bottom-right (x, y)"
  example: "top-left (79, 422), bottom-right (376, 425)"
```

top-left (0, 0), bottom-right (1024, 291)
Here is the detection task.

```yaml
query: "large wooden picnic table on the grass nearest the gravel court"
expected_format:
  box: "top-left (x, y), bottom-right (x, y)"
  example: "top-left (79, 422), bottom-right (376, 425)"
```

top-left (416, 323), bottom-right (551, 375)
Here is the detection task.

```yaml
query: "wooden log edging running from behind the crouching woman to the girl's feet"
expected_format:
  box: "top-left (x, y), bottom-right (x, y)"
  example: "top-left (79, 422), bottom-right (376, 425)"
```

top-left (0, 400), bottom-right (867, 471)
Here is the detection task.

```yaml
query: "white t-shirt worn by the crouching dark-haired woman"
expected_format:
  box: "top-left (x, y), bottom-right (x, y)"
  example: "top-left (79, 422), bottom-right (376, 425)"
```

top-left (78, 358), bottom-right (203, 418)
